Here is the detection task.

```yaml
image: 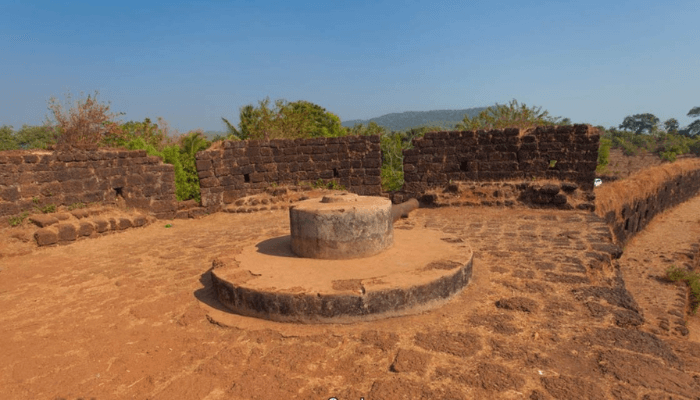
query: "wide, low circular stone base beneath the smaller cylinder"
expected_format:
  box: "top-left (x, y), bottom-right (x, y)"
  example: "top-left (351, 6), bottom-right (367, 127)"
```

top-left (211, 228), bottom-right (473, 323)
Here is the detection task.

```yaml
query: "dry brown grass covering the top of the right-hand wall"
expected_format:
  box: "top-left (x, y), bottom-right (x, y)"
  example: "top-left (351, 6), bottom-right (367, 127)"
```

top-left (595, 158), bottom-right (700, 217)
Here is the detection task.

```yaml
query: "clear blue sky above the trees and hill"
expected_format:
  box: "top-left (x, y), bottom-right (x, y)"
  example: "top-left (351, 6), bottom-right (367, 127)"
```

top-left (0, 0), bottom-right (700, 132)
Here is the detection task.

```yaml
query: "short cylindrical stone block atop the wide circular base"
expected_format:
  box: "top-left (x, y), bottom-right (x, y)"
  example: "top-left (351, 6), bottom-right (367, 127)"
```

top-left (289, 193), bottom-right (394, 260)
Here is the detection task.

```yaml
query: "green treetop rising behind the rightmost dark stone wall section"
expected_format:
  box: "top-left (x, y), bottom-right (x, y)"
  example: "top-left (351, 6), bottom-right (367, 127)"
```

top-left (455, 99), bottom-right (560, 131)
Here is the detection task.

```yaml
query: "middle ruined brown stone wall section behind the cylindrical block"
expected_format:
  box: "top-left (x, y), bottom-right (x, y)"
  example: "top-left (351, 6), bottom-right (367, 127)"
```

top-left (197, 136), bottom-right (382, 210)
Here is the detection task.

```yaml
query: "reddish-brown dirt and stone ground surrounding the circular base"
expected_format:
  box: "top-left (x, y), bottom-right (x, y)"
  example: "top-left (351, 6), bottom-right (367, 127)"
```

top-left (0, 197), bottom-right (700, 400)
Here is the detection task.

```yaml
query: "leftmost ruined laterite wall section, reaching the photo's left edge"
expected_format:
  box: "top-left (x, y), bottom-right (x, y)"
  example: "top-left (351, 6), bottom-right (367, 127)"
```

top-left (0, 148), bottom-right (177, 218)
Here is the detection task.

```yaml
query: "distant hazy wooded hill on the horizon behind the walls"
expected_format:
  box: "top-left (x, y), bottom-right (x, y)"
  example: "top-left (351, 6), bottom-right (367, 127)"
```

top-left (342, 107), bottom-right (486, 131)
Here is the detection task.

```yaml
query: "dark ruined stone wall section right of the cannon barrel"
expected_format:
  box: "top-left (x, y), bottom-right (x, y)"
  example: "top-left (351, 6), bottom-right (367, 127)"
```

top-left (403, 125), bottom-right (600, 197)
